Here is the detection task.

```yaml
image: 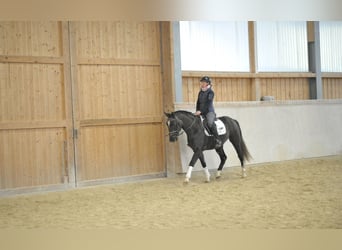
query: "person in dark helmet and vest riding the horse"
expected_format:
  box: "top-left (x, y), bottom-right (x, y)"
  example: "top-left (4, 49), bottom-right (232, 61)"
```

top-left (195, 76), bottom-right (222, 148)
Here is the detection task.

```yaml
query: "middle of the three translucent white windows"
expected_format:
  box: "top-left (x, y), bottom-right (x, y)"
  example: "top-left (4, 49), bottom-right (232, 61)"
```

top-left (256, 21), bottom-right (308, 72)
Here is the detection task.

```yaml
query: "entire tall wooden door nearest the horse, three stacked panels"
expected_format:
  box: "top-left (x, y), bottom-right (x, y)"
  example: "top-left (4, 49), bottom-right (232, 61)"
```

top-left (71, 22), bottom-right (165, 185)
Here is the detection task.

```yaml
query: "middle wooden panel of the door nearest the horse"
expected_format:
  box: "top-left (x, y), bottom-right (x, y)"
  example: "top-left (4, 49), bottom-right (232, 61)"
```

top-left (78, 65), bottom-right (162, 120)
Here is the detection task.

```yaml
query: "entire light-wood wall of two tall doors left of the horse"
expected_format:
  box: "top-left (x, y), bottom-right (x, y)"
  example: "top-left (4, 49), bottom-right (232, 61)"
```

top-left (0, 21), bottom-right (172, 194)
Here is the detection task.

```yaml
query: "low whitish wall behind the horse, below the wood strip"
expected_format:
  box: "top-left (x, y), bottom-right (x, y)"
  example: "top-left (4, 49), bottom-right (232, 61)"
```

top-left (175, 100), bottom-right (342, 171)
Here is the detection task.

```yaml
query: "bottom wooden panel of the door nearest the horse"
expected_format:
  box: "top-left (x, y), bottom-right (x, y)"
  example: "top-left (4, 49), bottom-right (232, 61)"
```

top-left (78, 123), bottom-right (163, 181)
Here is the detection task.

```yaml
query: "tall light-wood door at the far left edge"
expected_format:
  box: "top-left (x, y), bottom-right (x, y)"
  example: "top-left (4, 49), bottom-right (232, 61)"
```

top-left (0, 22), bottom-right (74, 191)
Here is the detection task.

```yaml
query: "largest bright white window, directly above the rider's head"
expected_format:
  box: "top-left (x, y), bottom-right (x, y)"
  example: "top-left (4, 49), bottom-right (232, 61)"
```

top-left (180, 21), bottom-right (249, 72)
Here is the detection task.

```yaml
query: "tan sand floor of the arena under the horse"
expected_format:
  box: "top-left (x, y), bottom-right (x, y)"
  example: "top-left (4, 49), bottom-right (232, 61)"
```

top-left (0, 155), bottom-right (342, 229)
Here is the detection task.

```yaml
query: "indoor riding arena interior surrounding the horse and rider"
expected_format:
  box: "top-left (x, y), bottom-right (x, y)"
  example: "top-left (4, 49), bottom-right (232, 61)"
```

top-left (0, 21), bottom-right (342, 229)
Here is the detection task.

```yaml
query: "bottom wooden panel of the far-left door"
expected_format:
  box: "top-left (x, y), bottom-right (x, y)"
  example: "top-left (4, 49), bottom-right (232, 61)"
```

top-left (0, 128), bottom-right (68, 189)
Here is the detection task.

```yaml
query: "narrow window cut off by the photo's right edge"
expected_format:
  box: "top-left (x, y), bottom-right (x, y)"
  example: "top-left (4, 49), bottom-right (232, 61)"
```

top-left (319, 22), bottom-right (342, 72)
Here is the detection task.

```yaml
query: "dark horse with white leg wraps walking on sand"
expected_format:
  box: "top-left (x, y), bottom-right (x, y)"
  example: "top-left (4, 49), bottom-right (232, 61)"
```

top-left (164, 110), bottom-right (252, 183)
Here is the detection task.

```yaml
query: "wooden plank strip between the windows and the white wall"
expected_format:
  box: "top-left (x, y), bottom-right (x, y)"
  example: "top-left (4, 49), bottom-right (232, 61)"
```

top-left (182, 72), bottom-right (342, 102)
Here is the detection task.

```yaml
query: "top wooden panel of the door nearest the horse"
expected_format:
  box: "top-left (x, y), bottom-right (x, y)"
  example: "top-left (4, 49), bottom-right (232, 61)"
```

top-left (74, 22), bottom-right (160, 61)
